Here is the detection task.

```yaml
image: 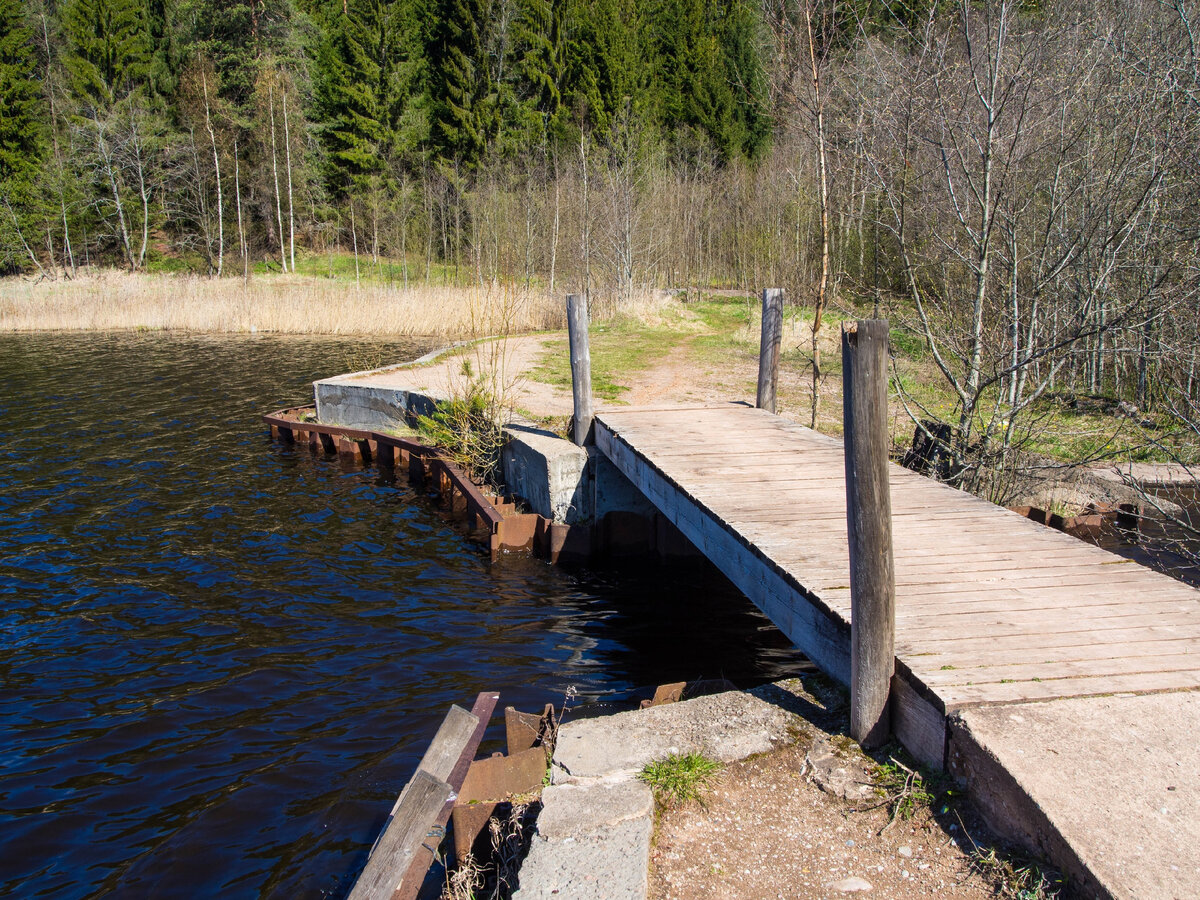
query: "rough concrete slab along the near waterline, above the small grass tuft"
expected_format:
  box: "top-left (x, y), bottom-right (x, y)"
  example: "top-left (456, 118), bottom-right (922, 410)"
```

top-left (552, 689), bottom-right (799, 784)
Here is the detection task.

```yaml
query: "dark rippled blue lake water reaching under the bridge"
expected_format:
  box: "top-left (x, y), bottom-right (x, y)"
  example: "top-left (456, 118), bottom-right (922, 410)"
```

top-left (0, 335), bottom-right (800, 898)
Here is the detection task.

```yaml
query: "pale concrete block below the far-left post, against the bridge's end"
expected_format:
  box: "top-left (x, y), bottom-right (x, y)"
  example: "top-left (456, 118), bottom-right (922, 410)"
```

top-left (502, 425), bottom-right (593, 524)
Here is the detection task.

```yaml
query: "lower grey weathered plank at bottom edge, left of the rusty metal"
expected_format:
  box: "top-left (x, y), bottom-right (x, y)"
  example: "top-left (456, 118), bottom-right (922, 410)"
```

top-left (349, 772), bottom-right (456, 900)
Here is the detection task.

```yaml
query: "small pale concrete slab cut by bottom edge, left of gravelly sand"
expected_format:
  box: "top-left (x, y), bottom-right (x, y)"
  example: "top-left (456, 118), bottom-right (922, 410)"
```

top-left (512, 816), bottom-right (654, 900)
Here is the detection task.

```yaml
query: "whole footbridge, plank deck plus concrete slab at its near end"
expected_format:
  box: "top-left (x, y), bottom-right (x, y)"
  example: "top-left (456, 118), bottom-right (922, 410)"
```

top-left (595, 404), bottom-right (1200, 898)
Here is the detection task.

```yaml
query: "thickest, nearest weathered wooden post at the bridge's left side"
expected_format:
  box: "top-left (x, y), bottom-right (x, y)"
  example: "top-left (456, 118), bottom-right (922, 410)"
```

top-left (841, 319), bottom-right (895, 748)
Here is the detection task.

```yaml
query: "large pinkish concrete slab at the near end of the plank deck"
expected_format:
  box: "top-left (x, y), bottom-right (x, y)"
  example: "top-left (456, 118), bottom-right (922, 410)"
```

top-left (950, 691), bottom-right (1200, 900)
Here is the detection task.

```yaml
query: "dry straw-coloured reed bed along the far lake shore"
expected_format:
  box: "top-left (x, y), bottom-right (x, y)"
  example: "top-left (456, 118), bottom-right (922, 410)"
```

top-left (0, 272), bottom-right (564, 337)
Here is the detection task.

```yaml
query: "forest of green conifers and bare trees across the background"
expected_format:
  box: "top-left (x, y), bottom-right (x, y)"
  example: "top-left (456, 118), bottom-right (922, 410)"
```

top-left (0, 0), bottom-right (1200, 487)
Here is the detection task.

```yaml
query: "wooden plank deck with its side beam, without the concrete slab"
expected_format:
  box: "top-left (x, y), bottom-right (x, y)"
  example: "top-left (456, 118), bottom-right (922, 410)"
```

top-left (596, 404), bottom-right (1200, 766)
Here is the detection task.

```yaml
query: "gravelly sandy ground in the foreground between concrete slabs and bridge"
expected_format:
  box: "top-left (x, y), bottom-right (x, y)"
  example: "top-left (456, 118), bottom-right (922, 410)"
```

top-left (650, 689), bottom-right (1041, 900)
